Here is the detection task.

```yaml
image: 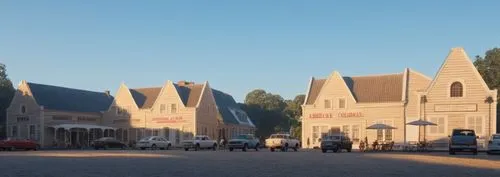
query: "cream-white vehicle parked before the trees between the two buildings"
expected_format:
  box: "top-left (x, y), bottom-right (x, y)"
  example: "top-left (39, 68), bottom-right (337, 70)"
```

top-left (266, 134), bottom-right (300, 152)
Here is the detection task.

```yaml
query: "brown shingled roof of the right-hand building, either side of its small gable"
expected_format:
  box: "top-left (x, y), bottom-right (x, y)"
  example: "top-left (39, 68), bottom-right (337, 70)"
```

top-left (306, 73), bottom-right (404, 105)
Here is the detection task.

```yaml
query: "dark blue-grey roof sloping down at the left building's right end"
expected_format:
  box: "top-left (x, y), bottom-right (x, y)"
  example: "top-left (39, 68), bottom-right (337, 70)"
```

top-left (212, 89), bottom-right (253, 124)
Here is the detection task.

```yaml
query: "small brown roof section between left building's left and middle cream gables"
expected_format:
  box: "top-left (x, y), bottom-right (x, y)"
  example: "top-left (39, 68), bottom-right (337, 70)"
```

top-left (130, 87), bottom-right (162, 109)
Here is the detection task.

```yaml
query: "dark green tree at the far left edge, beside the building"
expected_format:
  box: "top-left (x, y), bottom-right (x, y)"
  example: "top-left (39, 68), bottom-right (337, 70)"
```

top-left (0, 63), bottom-right (15, 137)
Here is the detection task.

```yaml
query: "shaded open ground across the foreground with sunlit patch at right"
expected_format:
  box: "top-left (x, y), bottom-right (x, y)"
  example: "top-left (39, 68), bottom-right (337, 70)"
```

top-left (0, 150), bottom-right (500, 177)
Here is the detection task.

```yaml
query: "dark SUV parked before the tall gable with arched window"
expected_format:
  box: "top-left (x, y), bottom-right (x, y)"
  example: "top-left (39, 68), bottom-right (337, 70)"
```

top-left (449, 129), bottom-right (478, 155)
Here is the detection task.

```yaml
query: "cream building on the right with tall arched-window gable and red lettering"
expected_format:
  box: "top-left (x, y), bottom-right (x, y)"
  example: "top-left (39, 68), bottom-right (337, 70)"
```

top-left (302, 48), bottom-right (497, 148)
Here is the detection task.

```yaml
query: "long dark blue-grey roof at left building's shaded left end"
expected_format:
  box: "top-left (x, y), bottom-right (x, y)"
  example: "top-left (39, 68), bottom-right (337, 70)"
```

top-left (28, 83), bottom-right (113, 113)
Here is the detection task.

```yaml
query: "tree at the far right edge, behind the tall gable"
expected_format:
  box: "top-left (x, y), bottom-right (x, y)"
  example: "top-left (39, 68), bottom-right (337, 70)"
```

top-left (474, 48), bottom-right (500, 99)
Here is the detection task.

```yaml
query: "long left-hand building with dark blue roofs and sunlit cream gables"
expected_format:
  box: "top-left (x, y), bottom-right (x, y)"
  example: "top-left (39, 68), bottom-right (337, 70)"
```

top-left (6, 81), bottom-right (256, 147)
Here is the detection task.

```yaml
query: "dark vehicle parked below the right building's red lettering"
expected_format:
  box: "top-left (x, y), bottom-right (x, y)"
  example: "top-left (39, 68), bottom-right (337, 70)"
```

top-left (321, 134), bottom-right (352, 153)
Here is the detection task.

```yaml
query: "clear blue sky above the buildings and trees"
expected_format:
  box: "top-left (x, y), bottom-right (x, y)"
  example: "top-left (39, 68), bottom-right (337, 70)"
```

top-left (0, 0), bottom-right (500, 101)
